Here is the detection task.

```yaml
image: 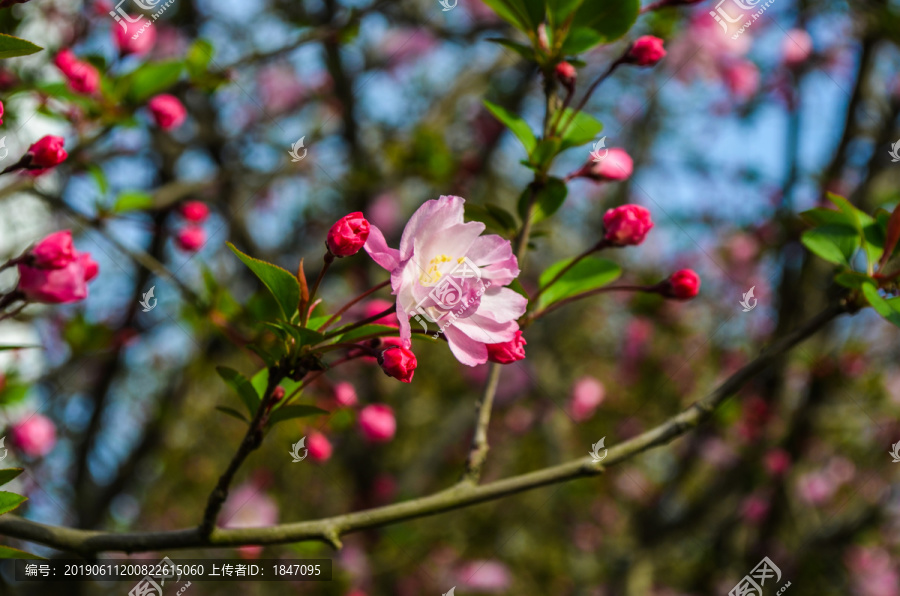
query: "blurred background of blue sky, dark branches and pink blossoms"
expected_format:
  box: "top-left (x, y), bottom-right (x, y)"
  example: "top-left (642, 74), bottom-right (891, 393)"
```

top-left (0, 0), bottom-right (900, 596)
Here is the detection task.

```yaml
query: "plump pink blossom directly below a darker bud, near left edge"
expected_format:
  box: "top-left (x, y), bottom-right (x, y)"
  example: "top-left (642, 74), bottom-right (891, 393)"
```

top-left (16, 252), bottom-right (99, 304)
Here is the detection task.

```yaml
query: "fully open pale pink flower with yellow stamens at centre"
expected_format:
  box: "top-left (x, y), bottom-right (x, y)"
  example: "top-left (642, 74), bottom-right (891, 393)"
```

top-left (365, 196), bottom-right (527, 366)
